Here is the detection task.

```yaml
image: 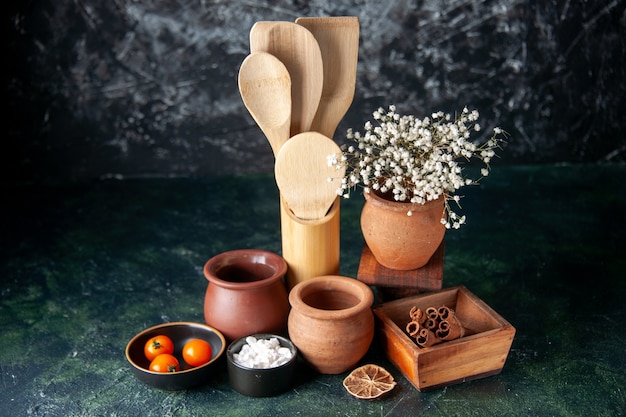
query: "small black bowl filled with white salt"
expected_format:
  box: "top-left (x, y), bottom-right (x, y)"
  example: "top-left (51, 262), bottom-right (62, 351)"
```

top-left (226, 333), bottom-right (298, 397)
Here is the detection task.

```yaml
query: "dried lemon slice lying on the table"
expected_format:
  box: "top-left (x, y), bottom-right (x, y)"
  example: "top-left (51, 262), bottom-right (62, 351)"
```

top-left (343, 364), bottom-right (396, 400)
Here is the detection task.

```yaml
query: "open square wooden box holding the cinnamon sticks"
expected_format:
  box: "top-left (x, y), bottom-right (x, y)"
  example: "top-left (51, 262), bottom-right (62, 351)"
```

top-left (374, 286), bottom-right (515, 391)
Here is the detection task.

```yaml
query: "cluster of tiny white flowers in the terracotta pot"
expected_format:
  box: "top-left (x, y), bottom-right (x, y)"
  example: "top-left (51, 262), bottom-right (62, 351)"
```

top-left (328, 105), bottom-right (506, 229)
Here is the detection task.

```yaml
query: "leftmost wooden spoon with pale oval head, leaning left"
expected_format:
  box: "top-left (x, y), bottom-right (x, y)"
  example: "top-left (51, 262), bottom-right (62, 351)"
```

top-left (238, 52), bottom-right (291, 156)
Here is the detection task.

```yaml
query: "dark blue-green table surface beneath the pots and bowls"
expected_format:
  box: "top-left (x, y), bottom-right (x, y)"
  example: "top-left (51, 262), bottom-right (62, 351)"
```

top-left (0, 165), bottom-right (626, 416)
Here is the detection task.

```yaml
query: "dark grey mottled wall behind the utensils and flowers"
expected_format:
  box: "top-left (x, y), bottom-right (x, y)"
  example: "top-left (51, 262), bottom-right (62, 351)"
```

top-left (6, 0), bottom-right (626, 182)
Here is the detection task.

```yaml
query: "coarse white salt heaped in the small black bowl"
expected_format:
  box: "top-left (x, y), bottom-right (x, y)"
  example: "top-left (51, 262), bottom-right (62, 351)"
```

top-left (233, 336), bottom-right (293, 369)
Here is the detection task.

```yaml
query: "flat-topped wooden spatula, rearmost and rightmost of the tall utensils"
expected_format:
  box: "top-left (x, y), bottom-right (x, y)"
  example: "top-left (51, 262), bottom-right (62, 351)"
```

top-left (296, 16), bottom-right (359, 138)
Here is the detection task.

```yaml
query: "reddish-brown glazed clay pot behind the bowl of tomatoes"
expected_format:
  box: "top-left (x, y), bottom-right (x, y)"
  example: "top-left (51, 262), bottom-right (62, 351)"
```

top-left (204, 249), bottom-right (289, 341)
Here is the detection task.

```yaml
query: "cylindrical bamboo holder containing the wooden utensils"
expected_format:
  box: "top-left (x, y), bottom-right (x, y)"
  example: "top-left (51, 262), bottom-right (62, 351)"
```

top-left (280, 197), bottom-right (340, 289)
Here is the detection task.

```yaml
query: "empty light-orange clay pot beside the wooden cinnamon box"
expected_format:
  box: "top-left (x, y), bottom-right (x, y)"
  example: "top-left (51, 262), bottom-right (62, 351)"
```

top-left (288, 275), bottom-right (374, 374)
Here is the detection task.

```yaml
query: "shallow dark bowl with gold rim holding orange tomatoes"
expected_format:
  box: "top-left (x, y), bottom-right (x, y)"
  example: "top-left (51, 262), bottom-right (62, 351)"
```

top-left (126, 322), bottom-right (226, 391)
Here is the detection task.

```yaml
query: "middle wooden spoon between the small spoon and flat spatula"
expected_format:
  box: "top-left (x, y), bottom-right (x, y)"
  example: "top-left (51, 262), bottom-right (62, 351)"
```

top-left (250, 21), bottom-right (324, 136)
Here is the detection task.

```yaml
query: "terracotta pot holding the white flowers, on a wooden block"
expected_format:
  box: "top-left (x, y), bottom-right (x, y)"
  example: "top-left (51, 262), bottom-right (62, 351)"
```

top-left (361, 191), bottom-right (446, 271)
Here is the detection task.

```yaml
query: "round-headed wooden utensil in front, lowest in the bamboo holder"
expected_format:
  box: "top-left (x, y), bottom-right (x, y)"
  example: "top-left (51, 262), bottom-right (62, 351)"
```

top-left (274, 132), bottom-right (345, 220)
